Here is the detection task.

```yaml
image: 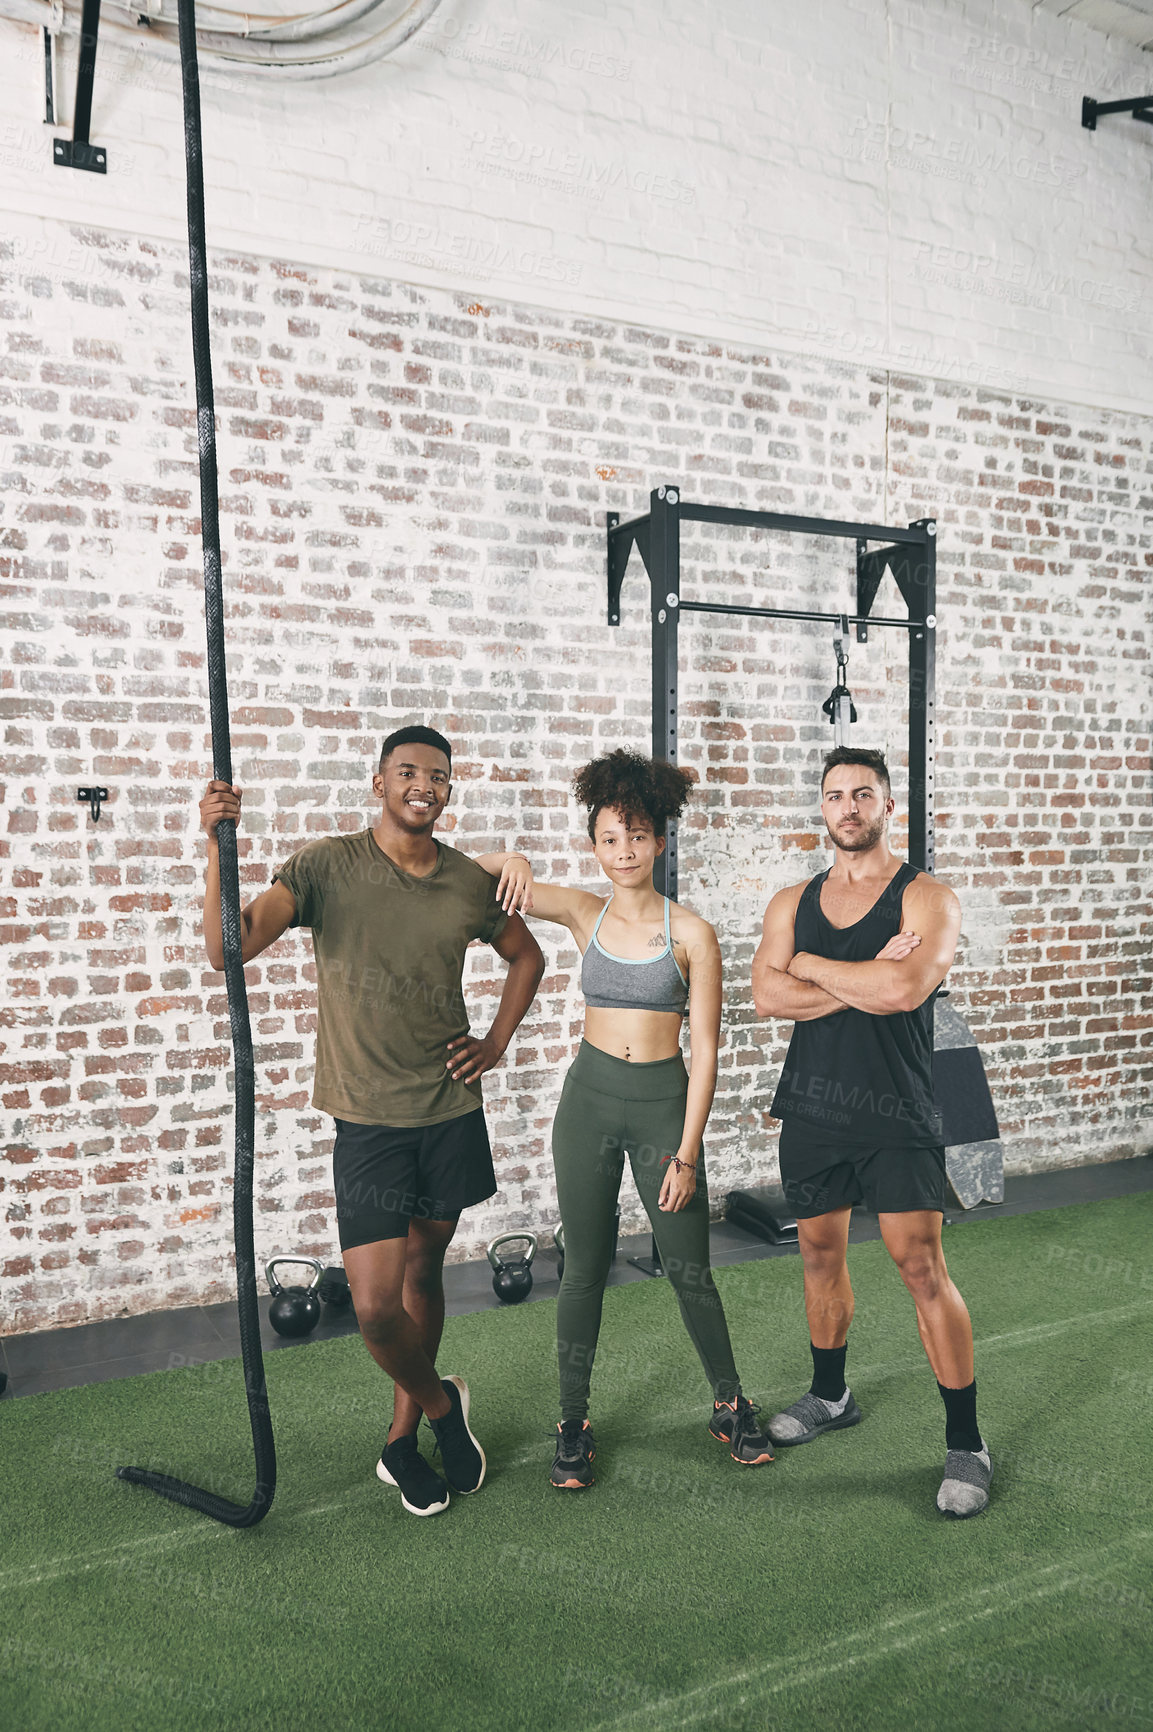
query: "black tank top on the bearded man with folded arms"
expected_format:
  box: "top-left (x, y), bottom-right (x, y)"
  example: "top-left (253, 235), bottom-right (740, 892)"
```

top-left (769, 861), bottom-right (942, 1147)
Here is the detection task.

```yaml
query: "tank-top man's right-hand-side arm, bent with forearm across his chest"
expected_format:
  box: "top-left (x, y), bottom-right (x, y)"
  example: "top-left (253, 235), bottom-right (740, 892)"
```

top-left (789, 873), bottom-right (961, 1017)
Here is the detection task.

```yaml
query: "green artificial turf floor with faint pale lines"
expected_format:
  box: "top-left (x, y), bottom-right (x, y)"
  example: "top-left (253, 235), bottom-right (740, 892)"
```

top-left (0, 1195), bottom-right (1153, 1732)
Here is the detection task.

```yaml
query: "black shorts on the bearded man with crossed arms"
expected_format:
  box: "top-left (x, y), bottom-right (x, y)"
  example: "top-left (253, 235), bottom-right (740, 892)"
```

top-left (781, 1119), bottom-right (945, 1221)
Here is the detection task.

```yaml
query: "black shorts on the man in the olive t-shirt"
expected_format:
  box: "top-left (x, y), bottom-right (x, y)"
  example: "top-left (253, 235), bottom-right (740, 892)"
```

top-left (332, 1107), bottom-right (497, 1251)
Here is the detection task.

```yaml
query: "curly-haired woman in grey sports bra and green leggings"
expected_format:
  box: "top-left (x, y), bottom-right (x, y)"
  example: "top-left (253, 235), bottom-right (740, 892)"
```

top-left (480, 750), bottom-right (772, 1491)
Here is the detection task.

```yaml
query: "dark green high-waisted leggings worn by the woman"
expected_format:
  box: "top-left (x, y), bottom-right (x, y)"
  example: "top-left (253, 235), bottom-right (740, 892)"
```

top-left (552, 1041), bottom-right (739, 1419)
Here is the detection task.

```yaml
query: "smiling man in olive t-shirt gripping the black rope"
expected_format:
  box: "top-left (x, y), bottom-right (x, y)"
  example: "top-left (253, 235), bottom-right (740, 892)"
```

top-left (201, 727), bottom-right (544, 1516)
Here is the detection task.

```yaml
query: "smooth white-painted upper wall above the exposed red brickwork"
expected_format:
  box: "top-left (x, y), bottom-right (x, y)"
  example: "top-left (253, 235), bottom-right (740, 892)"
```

top-left (0, 0), bottom-right (1153, 409)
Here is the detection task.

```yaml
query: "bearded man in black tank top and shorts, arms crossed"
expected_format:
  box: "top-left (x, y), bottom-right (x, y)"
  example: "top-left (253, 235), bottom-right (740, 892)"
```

top-left (753, 746), bottom-right (992, 1516)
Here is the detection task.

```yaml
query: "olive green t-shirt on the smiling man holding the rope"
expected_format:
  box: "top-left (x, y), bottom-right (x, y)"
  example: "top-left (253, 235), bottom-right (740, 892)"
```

top-left (274, 830), bottom-right (509, 1126)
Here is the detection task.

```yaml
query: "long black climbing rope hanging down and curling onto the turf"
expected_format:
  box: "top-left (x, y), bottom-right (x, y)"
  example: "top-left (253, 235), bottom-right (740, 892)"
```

top-left (116, 0), bottom-right (277, 1528)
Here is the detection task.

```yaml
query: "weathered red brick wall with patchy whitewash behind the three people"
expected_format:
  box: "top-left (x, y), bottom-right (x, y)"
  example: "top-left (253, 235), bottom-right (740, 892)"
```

top-left (0, 230), bottom-right (1153, 1328)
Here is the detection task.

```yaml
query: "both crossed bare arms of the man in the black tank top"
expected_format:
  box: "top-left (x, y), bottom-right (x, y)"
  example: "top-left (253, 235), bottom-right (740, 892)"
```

top-left (753, 873), bottom-right (961, 1022)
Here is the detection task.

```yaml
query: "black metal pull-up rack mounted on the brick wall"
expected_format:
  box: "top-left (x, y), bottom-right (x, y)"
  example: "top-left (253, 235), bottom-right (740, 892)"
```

top-left (608, 485), bottom-right (937, 895)
